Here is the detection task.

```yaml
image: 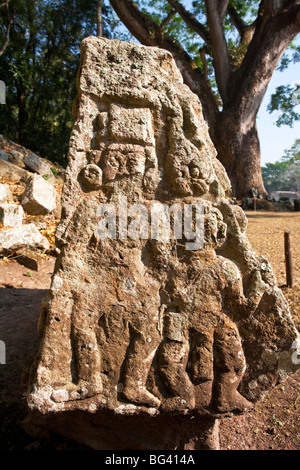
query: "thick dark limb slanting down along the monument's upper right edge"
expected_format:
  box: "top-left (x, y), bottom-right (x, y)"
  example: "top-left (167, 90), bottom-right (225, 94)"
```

top-left (110, 0), bottom-right (219, 126)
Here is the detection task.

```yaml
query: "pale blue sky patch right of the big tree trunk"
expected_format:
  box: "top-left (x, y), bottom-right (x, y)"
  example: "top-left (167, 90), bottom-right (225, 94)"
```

top-left (257, 53), bottom-right (300, 166)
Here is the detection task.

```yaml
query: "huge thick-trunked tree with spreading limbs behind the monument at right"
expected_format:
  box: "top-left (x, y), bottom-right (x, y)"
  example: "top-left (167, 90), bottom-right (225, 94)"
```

top-left (110, 0), bottom-right (300, 198)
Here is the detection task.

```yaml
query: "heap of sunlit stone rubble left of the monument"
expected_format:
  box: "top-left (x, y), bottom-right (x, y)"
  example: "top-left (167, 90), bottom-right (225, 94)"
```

top-left (0, 135), bottom-right (64, 258)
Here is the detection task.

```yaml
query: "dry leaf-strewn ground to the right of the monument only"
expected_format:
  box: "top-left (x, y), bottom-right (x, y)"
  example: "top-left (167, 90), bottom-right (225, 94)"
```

top-left (220, 212), bottom-right (300, 450)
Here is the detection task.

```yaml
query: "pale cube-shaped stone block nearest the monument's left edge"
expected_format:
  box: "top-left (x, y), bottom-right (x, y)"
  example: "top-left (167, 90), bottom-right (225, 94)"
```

top-left (21, 174), bottom-right (56, 215)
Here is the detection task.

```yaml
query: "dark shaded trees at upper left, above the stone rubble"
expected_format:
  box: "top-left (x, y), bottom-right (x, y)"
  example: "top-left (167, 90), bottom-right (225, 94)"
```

top-left (0, 0), bottom-right (123, 164)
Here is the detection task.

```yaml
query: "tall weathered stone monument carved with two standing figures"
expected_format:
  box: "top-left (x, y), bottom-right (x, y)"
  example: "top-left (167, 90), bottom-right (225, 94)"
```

top-left (28, 37), bottom-right (299, 450)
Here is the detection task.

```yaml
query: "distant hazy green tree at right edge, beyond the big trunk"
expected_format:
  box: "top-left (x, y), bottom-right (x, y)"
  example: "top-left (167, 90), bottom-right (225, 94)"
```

top-left (262, 139), bottom-right (300, 192)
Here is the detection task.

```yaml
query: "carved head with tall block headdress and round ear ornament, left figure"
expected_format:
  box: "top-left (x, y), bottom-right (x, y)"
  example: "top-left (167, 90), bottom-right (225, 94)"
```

top-left (82, 103), bottom-right (158, 191)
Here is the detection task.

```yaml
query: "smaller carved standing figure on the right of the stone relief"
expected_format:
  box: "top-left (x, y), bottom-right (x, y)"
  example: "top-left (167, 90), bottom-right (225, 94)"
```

top-left (159, 208), bottom-right (252, 412)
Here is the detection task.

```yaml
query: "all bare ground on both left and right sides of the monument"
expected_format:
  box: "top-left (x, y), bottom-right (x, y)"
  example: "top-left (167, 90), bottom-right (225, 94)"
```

top-left (0, 212), bottom-right (300, 450)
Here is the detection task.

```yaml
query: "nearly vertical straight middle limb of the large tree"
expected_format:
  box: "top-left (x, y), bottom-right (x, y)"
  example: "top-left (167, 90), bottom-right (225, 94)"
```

top-left (205, 0), bottom-right (231, 106)
